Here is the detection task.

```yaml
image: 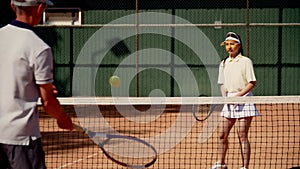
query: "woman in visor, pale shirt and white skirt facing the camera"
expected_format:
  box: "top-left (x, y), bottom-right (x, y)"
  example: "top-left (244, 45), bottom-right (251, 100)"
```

top-left (211, 32), bottom-right (259, 169)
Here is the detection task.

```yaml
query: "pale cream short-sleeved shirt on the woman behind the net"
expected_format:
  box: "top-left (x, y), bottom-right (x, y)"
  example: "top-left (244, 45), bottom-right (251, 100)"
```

top-left (218, 55), bottom-right (256, 93)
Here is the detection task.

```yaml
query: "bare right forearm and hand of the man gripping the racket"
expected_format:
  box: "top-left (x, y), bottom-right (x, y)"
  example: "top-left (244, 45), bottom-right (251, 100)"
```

top-left (39, 83), bottom-right (73, 130)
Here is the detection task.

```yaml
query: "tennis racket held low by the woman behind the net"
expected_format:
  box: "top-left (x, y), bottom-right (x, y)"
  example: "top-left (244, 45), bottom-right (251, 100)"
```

top-left (192, 104), bottom-right (224, 121)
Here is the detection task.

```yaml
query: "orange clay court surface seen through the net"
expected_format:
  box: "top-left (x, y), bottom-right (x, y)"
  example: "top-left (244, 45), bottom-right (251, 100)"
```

top-left (40, 101), bottom-right (300, 169)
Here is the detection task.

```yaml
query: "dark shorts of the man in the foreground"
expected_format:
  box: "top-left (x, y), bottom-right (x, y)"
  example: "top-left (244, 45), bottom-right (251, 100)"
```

top-left (0, 138), bottom-right (46, 169)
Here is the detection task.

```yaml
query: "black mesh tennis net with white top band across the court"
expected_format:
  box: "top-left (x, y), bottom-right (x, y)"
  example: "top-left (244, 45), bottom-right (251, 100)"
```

top-left (38, 96), bottom-right (300, 169)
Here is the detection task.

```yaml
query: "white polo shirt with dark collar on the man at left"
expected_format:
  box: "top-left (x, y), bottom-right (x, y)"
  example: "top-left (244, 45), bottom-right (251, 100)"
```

top-left (0, 21), bottom-right (53, 145)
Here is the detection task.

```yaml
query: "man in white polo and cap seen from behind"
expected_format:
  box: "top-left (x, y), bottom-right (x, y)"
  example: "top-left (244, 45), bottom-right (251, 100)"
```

top-left (0, 0), bottom-right (73, 169)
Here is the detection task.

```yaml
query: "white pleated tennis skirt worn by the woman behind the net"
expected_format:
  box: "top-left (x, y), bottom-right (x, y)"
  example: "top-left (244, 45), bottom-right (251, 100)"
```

top-left (221, 92), bottom-right (260, 118)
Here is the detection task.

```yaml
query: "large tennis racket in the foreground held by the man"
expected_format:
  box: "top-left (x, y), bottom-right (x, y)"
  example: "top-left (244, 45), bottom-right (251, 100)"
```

top-left (73, 124), bottom-right (157, 168)
